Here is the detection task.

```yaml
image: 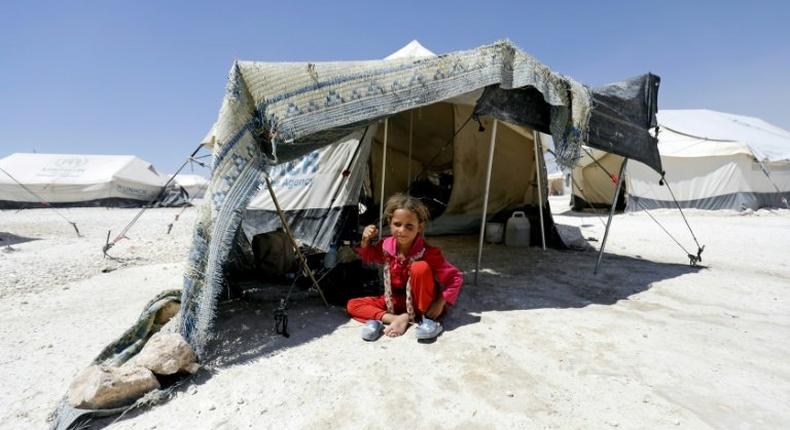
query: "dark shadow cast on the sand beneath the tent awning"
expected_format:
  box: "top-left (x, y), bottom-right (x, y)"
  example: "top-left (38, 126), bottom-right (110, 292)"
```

top-left (91, 232), bottom-right (703, 428)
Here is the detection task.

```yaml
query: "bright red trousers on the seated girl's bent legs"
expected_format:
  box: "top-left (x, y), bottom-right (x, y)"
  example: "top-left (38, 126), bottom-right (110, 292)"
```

top-left (346, 261), bottom-right (437, 322)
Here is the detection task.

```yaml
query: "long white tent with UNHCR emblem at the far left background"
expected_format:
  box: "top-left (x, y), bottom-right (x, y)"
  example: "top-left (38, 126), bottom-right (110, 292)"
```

top-left (0, 153), bottom-right (167, 208)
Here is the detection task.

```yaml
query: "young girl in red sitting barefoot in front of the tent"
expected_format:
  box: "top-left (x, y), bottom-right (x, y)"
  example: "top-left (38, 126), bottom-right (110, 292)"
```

top-left (346, 194), bottom-right (464, 340)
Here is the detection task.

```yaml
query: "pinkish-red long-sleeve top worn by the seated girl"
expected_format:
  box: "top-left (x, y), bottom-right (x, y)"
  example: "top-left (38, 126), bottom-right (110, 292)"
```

top-left (356, 235), bottom-right (464, 305)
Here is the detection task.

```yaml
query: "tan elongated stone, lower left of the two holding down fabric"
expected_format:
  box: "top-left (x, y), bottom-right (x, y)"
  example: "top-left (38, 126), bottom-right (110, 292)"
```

top-left (68, 364), bottom-right (159, 409)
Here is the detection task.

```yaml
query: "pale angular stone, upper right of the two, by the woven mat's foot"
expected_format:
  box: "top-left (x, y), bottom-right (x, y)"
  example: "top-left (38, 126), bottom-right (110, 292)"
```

top-left (124, 331), bottom-right (200, 375)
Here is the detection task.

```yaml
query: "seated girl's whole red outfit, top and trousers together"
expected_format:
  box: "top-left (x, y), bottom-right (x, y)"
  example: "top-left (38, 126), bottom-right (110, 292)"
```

top-left (346, 235), bottom-right (464, 322)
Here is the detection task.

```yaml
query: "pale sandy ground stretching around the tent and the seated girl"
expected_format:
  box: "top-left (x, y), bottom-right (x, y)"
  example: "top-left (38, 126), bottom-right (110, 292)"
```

top-left (0, 197), bottom-right (790, 429)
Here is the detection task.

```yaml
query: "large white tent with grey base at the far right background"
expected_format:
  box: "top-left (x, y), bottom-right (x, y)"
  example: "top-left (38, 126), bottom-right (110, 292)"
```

top-left (626, 110), bottom-right (790, 210)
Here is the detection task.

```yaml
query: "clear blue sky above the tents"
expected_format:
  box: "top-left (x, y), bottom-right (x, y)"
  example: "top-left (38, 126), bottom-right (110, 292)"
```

top-left (0, 0), bottom-right (790, 172)
